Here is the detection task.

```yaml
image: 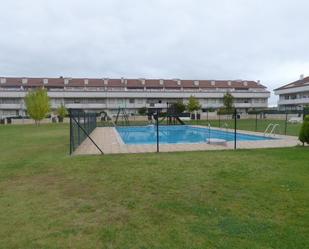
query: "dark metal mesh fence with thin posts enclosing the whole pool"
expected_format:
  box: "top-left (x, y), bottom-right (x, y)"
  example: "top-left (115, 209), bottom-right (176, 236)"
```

top-left (69, 108), bottom-right (309, 154)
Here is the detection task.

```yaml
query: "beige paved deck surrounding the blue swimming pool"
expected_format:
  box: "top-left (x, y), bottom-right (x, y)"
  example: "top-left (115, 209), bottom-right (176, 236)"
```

top-left (74, 126), bottom-right (300, 155)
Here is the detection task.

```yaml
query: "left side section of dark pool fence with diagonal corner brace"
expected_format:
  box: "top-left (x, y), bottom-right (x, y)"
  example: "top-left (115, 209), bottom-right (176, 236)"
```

top-left (69, 109), bottom-right (103, 154)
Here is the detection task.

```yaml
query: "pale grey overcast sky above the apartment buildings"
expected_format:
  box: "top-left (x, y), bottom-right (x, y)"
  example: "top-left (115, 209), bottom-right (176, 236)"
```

top-left (0, 0), bottom-right (309, 104)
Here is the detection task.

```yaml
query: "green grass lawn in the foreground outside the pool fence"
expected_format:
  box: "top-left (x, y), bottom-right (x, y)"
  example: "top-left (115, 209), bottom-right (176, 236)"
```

top-left (0, 124), bottom-right (309, 249)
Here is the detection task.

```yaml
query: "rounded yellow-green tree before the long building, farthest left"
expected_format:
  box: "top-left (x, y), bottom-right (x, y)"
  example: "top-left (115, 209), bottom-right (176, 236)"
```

top-left (25, 88), bottom-right (50, 125)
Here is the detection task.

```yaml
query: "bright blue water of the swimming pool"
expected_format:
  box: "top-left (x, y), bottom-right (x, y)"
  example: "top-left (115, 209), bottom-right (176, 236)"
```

top-left (117, 125), bottom-right (271, 144)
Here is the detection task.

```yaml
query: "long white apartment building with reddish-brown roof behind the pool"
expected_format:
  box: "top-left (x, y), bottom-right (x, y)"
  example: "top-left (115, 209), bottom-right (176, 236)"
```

top-left (0, 77), bottom-right (270, 118)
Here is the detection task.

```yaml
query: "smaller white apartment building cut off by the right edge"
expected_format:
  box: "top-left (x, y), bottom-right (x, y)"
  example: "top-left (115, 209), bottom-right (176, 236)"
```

top-left (274, 75), bottom-right (309, 110)
